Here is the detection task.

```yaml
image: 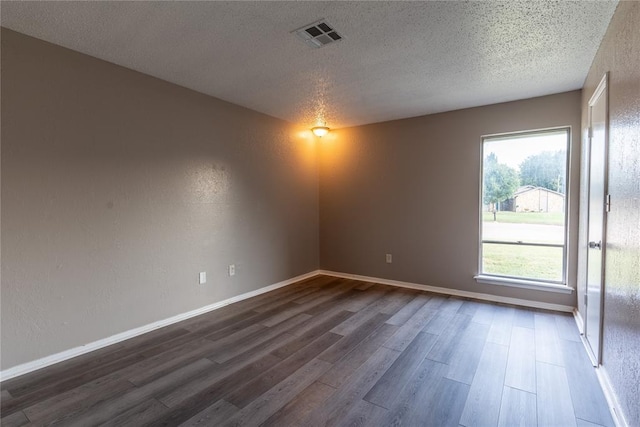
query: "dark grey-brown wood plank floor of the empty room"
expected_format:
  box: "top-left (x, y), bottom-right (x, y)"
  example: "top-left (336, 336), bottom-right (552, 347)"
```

top-left (1, 276), bottom-right (613, 426)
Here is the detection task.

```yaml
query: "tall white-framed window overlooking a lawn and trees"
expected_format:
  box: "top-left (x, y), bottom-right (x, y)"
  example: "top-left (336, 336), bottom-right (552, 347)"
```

top-left (476, 128), bottom-right (569, 287)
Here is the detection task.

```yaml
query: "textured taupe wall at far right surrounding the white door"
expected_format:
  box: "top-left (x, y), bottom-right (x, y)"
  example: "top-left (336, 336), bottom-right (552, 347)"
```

top-left (578, 2), bottom-right (640, 426)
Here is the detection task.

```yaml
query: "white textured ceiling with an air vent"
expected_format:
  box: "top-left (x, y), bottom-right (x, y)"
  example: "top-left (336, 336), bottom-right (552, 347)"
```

top-left (1, 1), bottom-right (617, 128)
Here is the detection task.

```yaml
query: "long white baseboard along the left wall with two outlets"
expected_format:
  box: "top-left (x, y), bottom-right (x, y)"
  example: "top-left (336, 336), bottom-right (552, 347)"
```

top-left (0, 270), bottom-right (319, 382)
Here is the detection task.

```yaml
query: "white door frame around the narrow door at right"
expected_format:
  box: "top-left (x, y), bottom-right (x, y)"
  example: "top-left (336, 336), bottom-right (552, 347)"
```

top-left (583, 72), bottom-right (609, 367)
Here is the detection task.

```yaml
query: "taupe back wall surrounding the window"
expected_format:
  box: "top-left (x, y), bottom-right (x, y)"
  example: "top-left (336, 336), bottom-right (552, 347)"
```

top-left (320, 91), bottom-right (581, 306)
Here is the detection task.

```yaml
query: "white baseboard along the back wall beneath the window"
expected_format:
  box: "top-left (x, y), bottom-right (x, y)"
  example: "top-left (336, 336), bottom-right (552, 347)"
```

top-left (319, 270), bottom-right (573, 313)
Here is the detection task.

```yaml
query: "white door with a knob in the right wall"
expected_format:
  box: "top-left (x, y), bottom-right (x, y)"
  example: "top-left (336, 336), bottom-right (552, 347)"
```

top-left (585, 74), bottom-right (608, 364)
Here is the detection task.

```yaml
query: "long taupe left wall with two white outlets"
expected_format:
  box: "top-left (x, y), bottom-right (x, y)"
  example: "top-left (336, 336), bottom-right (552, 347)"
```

top-left (1, 29), bottom-right (318, 369)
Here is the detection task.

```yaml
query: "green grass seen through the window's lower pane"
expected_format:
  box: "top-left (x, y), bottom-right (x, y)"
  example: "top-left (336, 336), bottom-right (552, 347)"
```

top-left (482, 244), bottom-right (562, 281)
